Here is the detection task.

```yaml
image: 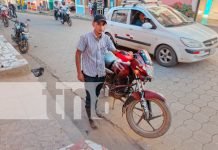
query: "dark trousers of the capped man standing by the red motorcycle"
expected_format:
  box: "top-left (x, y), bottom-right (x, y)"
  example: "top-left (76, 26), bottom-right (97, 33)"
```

top-left (83, 74), bottom-right (105, 109)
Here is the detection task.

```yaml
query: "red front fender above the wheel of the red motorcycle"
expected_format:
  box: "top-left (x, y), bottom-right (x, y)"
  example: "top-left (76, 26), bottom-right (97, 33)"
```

top-left (122, 90), bottom-right (166, 115)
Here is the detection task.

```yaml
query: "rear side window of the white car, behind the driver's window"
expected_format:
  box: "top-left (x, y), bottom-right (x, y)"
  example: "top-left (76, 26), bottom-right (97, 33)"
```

top-left (111, 9), bottom-right (129, 23)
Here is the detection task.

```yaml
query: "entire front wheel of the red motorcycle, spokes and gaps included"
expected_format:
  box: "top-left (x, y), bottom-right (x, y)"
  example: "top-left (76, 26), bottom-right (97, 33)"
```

top-left (126, 99), bottom-right (171, 138)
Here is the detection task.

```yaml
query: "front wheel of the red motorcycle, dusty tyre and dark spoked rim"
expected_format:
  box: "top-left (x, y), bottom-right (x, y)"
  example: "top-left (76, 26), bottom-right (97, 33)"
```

top-left (126, 99), bottom-right (171, 138)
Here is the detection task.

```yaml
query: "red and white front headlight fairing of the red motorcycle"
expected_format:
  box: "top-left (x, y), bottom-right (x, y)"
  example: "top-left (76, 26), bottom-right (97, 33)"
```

top-left (131, 50), bottom-right (153, 80)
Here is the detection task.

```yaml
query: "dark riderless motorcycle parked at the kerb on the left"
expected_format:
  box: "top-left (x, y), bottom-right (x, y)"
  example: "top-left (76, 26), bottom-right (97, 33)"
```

top-left (11, 19), bottom-right (30, 54)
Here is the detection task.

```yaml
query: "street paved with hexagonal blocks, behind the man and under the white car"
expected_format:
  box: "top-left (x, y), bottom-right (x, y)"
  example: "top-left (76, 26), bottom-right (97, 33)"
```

top-left (1, 15), bottom-right (218, 150)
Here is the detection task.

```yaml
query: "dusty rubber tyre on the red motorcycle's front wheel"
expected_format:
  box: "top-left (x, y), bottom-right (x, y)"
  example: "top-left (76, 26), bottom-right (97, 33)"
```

top-left (126, 99), bottom-right (171, 138)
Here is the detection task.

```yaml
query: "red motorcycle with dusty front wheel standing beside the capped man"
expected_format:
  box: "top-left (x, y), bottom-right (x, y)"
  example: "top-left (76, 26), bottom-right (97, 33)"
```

top-left (104, 50), bottom-right (171, 138)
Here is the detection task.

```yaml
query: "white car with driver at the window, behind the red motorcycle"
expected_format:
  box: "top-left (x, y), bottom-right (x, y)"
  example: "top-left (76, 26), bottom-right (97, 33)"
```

top-left (105, 3), bottom-right (218, 67)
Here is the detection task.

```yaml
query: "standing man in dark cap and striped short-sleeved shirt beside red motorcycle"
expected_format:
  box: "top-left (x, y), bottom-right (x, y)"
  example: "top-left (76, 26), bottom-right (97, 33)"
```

top-left (76, 15), bottom-right (116, 129)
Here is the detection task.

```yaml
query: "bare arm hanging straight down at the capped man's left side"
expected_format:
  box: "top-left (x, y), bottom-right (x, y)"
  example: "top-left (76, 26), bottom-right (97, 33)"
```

top-left (75, 49), bottom-right (84, 82)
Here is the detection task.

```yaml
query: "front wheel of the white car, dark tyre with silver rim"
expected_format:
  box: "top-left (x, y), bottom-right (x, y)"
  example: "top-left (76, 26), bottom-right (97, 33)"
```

top-left (155, 45), bottom-right (178, 67)
